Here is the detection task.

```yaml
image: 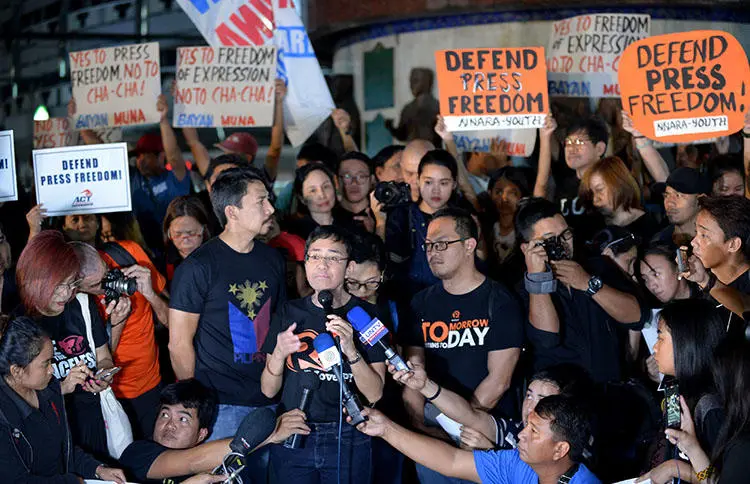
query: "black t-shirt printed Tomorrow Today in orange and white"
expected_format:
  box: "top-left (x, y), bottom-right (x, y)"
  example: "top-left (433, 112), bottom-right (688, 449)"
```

top-left (406, 278), bottom-right (524, 399)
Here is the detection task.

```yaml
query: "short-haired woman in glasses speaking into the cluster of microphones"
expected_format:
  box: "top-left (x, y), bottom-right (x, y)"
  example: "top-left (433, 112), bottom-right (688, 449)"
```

top-left (261, 225), bottom-right (385, 484)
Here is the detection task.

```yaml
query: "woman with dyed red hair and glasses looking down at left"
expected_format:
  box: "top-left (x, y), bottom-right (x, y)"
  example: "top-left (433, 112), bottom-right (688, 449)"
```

top-left (14, 230), bottom-right (114, 459)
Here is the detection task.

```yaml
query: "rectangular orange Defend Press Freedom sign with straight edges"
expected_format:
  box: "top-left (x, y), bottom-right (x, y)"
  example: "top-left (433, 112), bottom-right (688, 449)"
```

top-left (435, 47), bottom-right (549, 131)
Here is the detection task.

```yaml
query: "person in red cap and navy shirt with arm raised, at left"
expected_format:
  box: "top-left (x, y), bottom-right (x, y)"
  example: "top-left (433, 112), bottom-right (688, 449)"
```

top-left (130, 94), bottom-right (190, 251)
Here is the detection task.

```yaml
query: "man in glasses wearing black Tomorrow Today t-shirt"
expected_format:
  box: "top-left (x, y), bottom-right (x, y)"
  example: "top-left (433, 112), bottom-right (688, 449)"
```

top-left (401, 208), bottom-right (523, 482)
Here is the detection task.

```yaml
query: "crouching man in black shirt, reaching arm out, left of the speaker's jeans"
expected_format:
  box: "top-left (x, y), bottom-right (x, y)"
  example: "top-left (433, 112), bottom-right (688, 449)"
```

top-left (120, 378), bottom-right (303, 484)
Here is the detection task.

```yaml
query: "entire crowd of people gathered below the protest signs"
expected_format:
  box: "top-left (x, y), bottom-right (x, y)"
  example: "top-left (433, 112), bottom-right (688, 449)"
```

top-left (0, 71), bottom-right (750, 484)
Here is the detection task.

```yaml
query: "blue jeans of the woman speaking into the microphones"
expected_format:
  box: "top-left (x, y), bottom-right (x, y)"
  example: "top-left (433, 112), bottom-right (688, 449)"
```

top-left (271, 422), bottom-right (372, 484)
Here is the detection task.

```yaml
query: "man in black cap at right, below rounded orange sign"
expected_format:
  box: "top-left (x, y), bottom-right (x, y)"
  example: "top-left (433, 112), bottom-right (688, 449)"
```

top-left (652, 167), bottom-right (708, 248)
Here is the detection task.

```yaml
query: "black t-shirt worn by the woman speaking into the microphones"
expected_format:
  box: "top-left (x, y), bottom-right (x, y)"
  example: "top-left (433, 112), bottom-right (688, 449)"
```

top-left (262, 296), bottom-right (385, 423)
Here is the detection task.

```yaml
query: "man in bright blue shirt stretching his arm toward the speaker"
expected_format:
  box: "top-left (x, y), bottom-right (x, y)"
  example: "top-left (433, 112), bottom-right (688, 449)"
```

top-left (357, 392), bottom-right (601, 484)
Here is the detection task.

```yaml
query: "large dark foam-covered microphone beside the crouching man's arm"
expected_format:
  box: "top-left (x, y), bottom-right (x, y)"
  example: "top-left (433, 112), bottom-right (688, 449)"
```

top-left (217, 408), bottom-right (276, 482)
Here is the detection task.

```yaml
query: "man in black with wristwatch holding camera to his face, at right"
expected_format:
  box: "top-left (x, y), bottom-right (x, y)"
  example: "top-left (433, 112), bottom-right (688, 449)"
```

top-left (515, 198), bottom-right (649, 382)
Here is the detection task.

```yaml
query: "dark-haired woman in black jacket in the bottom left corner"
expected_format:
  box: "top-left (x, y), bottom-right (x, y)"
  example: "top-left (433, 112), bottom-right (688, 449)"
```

top-left (0, 317), bottom-right (125, 484)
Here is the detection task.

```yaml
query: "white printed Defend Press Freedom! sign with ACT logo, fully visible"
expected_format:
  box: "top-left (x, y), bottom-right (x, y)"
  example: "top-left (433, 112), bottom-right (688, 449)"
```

top-left (32, 143), bottom-right (131, 216)
